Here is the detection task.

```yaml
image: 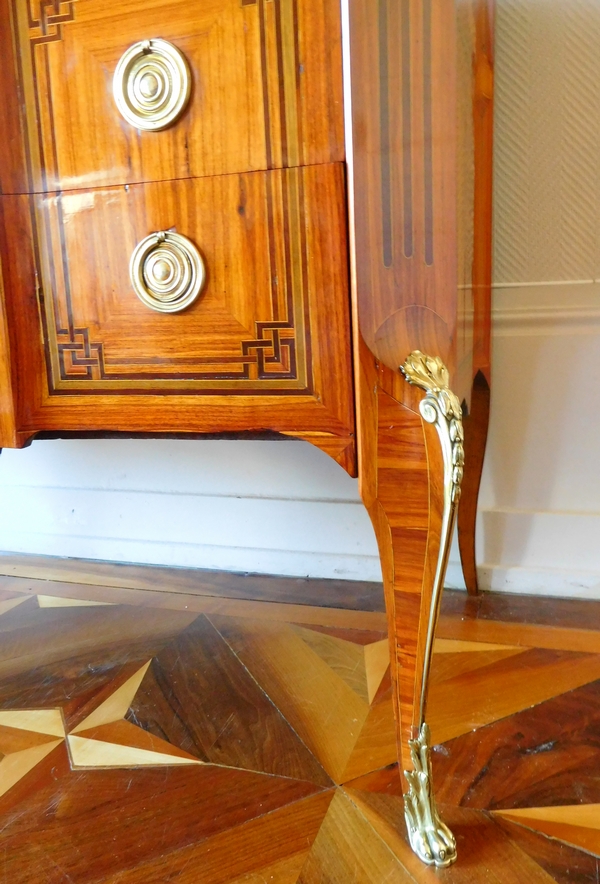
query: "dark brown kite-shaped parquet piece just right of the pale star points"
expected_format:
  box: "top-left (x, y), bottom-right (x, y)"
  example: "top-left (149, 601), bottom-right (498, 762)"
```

top-left (128, 617), bottom-right (331, 786)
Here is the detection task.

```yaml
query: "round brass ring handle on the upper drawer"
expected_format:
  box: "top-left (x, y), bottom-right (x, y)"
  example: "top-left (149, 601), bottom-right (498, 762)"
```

top-left (113, 40), bottom-right (192, 132)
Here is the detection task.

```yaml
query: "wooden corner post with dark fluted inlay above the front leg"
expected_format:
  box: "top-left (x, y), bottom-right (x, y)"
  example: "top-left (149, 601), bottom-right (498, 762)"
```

top-left (346, 0), bottom-right (460, 384)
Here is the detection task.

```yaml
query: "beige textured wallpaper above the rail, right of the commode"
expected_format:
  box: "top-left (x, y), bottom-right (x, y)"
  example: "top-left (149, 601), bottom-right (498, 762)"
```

top-left (494, 0), bottom-right (600, 284)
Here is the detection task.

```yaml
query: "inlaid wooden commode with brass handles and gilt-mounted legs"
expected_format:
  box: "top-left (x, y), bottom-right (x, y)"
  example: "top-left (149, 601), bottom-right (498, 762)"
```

top-left (0, 0), bottom-right (492, 866)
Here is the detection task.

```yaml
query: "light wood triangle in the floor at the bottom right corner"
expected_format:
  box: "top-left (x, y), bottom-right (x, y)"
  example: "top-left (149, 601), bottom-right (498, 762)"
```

top-left (495, 804), bottom-right (600, 856)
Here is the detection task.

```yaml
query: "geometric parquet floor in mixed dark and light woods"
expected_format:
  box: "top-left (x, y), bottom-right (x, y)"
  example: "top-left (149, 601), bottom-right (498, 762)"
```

top-left (0, 557), bottom-right (600, 884)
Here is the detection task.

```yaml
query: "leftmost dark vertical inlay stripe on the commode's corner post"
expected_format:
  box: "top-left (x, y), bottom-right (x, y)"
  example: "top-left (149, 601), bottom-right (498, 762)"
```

top-left (378, 0), bottom-right (393, 267)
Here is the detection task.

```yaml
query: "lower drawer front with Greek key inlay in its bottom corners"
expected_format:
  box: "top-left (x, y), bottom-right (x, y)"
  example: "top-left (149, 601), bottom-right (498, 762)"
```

top-left (2, 164), bottom-right (352, 432)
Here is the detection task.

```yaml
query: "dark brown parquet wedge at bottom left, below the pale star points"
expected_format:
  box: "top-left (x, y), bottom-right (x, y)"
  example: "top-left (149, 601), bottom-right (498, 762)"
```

top-left (0, 765), bottom-right (324, 884)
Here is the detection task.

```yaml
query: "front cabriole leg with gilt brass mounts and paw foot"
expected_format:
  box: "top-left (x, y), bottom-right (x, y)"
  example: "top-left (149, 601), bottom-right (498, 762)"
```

top-left (362, 350), bottom-right (463, 867)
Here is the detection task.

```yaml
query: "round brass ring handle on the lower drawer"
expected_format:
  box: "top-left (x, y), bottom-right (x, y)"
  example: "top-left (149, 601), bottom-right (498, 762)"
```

top-left (129, 231), bottom-right (206, 313)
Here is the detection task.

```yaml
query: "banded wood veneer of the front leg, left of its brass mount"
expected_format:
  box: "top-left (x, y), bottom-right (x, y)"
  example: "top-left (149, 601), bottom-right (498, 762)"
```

top-left (346, 346), bottom-right (443, 770)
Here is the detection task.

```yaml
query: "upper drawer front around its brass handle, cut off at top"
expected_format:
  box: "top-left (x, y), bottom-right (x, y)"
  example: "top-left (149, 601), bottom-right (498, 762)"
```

top-left (0, 0), bottom-right (344, 193)
